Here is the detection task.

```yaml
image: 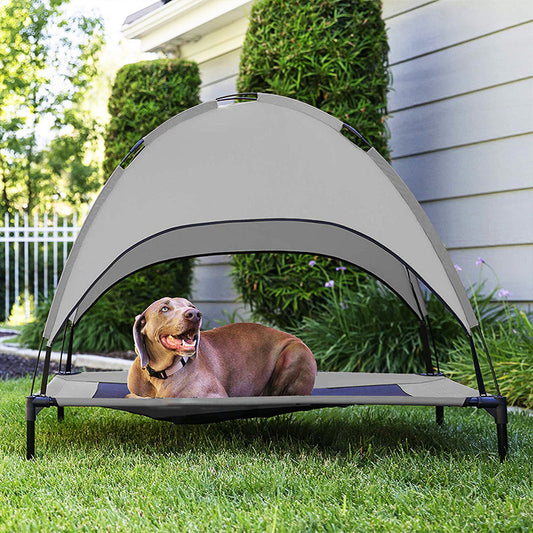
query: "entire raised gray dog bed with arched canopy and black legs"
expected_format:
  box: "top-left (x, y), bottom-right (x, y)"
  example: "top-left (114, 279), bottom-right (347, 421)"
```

top-left (26, 93), bottom-right (507, 460)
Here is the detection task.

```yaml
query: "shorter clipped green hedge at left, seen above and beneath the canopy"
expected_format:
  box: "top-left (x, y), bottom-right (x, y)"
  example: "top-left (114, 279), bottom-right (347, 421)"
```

top-left (23, 59), bottom-right (200, 352)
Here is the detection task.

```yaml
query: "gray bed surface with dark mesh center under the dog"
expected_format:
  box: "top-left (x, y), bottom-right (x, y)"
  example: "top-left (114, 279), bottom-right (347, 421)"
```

top-left (47, 371), bottom-right (479, 423)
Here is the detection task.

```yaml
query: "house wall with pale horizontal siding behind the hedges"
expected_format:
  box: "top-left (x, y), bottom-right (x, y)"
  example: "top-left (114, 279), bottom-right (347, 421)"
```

top-left (125, 0), bottom-right (533, 316)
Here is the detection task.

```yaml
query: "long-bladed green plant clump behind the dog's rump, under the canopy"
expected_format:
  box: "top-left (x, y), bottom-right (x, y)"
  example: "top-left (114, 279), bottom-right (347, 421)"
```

top-left (290, 262), bottom-right (504, 372)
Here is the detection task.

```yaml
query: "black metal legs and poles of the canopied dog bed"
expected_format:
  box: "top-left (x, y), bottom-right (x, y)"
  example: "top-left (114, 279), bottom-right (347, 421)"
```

top-left (26, 93), bottom-right (509, 462)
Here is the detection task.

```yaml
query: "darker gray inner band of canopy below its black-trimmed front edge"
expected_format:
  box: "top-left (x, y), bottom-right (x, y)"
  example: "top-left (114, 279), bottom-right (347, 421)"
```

top-left (75, 220), bottom-right (423, 323)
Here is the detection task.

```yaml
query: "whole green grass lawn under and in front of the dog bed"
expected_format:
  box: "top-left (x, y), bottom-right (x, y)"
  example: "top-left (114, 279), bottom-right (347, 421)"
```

top-left (0, 379), bottom-right (533, 533)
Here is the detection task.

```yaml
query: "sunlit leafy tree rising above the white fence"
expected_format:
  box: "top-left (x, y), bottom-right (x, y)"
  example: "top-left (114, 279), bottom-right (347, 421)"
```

top-left (0, 0), bottom-right (103, 213)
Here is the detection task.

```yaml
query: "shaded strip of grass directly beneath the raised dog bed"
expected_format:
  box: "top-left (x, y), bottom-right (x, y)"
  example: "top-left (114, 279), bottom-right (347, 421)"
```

top-left (37, 406), bottom-right (497, 461)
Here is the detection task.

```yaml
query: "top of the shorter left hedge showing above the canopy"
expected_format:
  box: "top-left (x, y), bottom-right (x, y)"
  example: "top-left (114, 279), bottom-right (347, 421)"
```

top-left (104, 59), bottom-right (200, 176)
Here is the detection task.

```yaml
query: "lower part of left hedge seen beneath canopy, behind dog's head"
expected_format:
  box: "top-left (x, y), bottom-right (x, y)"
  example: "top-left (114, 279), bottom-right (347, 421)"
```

top-left (20, 260), bottom-right (192, 353)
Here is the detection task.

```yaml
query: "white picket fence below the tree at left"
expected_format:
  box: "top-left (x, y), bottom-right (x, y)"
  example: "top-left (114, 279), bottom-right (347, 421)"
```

top-left (0, 213), bottom-right (80, 320)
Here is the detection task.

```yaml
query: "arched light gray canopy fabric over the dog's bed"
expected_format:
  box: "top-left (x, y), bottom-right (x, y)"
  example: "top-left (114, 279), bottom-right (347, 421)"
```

top-left (43, 94), bottom-right (477, 346)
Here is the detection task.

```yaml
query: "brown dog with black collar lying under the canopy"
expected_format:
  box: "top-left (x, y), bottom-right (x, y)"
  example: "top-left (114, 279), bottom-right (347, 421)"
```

top-left (128, 298), bottom-right (316, 398)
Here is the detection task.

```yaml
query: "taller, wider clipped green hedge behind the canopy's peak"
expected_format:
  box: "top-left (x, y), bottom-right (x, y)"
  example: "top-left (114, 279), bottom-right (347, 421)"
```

top-left (233, 0), bottom-right (390, 329)
